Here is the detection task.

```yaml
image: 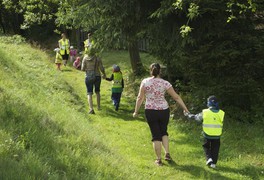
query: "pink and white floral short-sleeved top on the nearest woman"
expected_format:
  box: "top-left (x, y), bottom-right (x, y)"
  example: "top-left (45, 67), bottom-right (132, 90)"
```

top-left (141, 77), bottom-right (172, 110)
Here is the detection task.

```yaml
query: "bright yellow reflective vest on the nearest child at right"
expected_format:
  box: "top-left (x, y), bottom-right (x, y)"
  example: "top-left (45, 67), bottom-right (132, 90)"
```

top-left (203, 109), bottom-right (225, 136)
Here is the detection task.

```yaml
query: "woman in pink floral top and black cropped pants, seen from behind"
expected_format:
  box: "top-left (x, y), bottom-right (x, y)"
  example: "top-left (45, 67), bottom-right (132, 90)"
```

top-left (133, 63), bottom-right (189, 166)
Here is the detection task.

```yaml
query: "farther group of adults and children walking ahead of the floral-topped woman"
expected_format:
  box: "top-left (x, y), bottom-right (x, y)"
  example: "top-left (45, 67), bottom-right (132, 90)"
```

top-left (55, 33), bottom-right (124, 114)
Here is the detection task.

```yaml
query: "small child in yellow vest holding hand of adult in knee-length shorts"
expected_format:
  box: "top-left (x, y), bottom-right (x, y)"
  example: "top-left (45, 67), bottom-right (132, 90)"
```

top-left (106, 65), bottom-right (124, 111)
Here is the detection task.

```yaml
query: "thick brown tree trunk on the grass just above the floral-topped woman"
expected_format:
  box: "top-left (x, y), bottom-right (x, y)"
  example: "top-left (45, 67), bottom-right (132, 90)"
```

top-left (128, 41), bottom-right (144, 75)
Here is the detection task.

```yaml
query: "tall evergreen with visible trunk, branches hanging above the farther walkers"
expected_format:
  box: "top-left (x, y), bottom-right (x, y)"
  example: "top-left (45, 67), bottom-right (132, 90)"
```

top-left (55, 0), bottom-right (155, 74)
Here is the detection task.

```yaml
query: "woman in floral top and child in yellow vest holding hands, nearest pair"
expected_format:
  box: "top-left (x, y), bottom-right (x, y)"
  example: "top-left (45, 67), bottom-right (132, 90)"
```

top-left (133, 63), bottom-right (225, 168)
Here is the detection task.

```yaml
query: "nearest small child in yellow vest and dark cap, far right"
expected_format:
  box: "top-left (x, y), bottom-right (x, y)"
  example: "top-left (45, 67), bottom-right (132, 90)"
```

top-left (185, 96), bottom-right (225, 168)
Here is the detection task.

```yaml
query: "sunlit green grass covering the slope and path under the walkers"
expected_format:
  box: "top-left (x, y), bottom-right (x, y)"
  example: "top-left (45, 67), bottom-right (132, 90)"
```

top-left (0, 34), bottom-right (264, 180)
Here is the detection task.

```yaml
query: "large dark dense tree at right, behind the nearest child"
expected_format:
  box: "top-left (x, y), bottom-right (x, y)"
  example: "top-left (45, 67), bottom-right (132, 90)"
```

top-left (149, 0), bottom-right (264, 121)
